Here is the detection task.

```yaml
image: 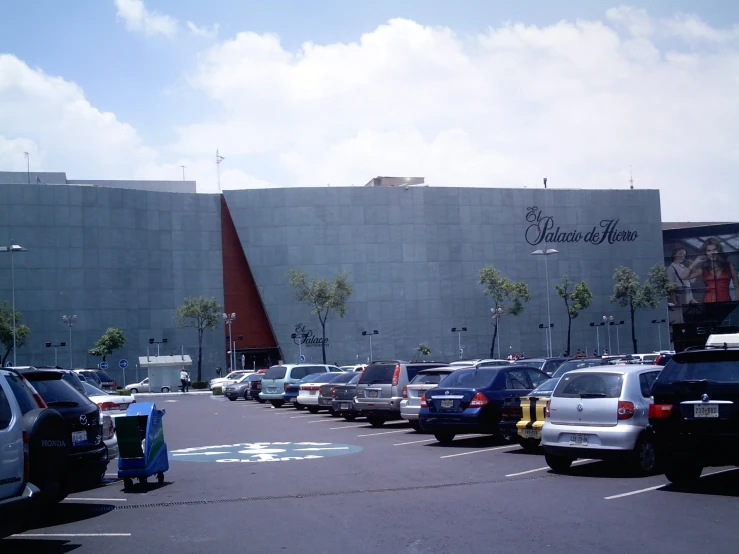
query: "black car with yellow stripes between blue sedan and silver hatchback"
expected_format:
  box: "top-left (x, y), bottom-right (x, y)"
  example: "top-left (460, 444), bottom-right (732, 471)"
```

top-left (499, 358), bottom-right (611, 451)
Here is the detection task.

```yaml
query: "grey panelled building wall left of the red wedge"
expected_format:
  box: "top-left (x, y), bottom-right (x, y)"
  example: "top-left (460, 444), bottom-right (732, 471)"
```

top-left (0, 184), bottom-right (225, 382)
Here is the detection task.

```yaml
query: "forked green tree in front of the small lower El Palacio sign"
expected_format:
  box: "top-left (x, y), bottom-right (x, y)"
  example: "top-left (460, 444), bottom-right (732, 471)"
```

top-left (287, 269), bottom-right (354, 364)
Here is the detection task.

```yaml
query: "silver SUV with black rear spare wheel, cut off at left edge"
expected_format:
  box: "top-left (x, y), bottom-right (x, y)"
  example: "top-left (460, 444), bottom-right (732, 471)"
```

top-left (0, 368), bottom-right (69, 538)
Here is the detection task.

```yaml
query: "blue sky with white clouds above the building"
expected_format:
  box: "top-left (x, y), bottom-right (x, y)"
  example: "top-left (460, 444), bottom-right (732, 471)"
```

top-left (0, 0), bottom-right (739, 221)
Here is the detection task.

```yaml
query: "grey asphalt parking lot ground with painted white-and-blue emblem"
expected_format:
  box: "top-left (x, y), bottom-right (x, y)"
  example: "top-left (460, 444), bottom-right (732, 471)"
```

top-left (0, 394), bottom-right (739, 553)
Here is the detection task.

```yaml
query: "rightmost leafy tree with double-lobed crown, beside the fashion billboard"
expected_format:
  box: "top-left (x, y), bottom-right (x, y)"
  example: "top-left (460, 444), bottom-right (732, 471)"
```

top-left (611, 264), bottom-right (675, 354)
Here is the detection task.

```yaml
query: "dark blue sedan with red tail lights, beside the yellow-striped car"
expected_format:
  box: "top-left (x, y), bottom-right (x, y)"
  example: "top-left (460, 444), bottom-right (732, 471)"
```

top-left (419, 365), bottom-right (549, 443)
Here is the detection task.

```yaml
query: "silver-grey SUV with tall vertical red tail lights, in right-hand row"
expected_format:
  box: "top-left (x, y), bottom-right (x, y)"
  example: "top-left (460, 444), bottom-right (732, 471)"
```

top-left (354, 360), bottom-right (446, 427)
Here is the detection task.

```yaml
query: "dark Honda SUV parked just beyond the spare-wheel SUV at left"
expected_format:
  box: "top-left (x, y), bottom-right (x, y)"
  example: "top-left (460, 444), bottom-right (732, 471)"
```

top-left (22, 369), bottom-right (108, 483)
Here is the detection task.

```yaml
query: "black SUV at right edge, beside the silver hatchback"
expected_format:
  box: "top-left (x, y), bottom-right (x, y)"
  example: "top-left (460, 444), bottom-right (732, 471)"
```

top-left (649, 346), bottom-right (739, 484)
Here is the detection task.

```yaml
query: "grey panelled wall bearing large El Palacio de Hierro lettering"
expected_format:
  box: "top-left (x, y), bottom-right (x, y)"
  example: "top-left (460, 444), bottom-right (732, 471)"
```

top-left (224, 187), bottom-right (667, 363)
